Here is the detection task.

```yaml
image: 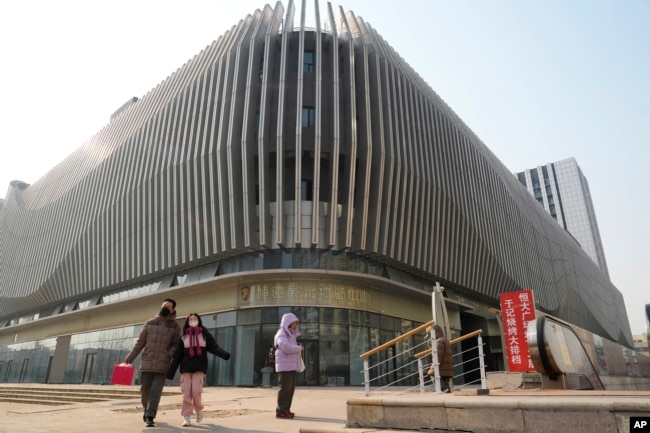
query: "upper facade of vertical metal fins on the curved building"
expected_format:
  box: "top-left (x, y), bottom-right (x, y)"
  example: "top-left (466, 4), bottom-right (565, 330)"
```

top-left (0, 0), bottom-right (629, 340)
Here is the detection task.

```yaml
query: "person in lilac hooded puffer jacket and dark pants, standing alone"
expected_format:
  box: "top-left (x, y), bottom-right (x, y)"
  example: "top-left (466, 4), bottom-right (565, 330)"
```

top-left (273, 313), bottom-right (303, 419)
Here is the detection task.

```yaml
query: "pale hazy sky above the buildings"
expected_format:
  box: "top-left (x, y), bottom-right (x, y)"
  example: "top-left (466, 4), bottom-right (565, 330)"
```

top-left (0, 0), bottom-right (650, 334)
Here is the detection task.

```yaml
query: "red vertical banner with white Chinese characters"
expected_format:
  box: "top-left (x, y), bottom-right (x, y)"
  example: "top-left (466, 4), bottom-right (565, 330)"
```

top-left (499, 290), bottom-right (535, 371)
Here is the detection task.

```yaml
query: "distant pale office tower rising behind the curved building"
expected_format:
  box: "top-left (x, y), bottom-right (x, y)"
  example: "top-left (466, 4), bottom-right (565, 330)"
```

top-left (517, 158), bottom-right (609, 277)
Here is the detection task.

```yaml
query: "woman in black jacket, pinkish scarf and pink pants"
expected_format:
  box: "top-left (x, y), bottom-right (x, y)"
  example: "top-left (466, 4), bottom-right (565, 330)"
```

top-left (167, 313), bottom-right (230, 426)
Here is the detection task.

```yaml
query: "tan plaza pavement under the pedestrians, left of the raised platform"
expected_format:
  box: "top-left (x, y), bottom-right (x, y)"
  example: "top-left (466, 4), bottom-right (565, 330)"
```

top-left (0, 385), bottom-right (362, 433)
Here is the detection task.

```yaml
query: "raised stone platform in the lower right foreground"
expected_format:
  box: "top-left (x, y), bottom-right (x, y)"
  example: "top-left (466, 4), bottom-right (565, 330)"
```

top-left (342, 389), bottom-right (650, 433)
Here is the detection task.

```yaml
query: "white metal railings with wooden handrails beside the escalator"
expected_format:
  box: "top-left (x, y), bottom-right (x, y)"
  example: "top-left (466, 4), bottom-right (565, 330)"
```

top-left (360, 321), bottom-right (487, 397)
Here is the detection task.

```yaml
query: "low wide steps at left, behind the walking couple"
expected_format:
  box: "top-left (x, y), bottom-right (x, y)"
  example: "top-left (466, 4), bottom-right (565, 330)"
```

top-left (0, 384), bottom-right (178, 406)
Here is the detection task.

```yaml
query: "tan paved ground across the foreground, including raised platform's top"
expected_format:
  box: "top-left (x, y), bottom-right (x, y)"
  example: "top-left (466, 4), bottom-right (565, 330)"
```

top-left (0, 384), bottom-right (650, 433)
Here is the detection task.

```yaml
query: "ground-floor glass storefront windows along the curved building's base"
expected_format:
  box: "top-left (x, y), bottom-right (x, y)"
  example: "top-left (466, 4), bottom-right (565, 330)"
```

top-left (0, 306), bottom-right (426, 386)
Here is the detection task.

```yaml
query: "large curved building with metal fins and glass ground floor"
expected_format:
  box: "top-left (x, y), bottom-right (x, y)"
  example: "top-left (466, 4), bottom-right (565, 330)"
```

top-left (0, 2), bottom-right (632, 385)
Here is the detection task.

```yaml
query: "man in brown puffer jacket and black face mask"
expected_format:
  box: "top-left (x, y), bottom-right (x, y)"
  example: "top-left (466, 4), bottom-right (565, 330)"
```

top-left (124, 298), bottom-right (181, 427)
